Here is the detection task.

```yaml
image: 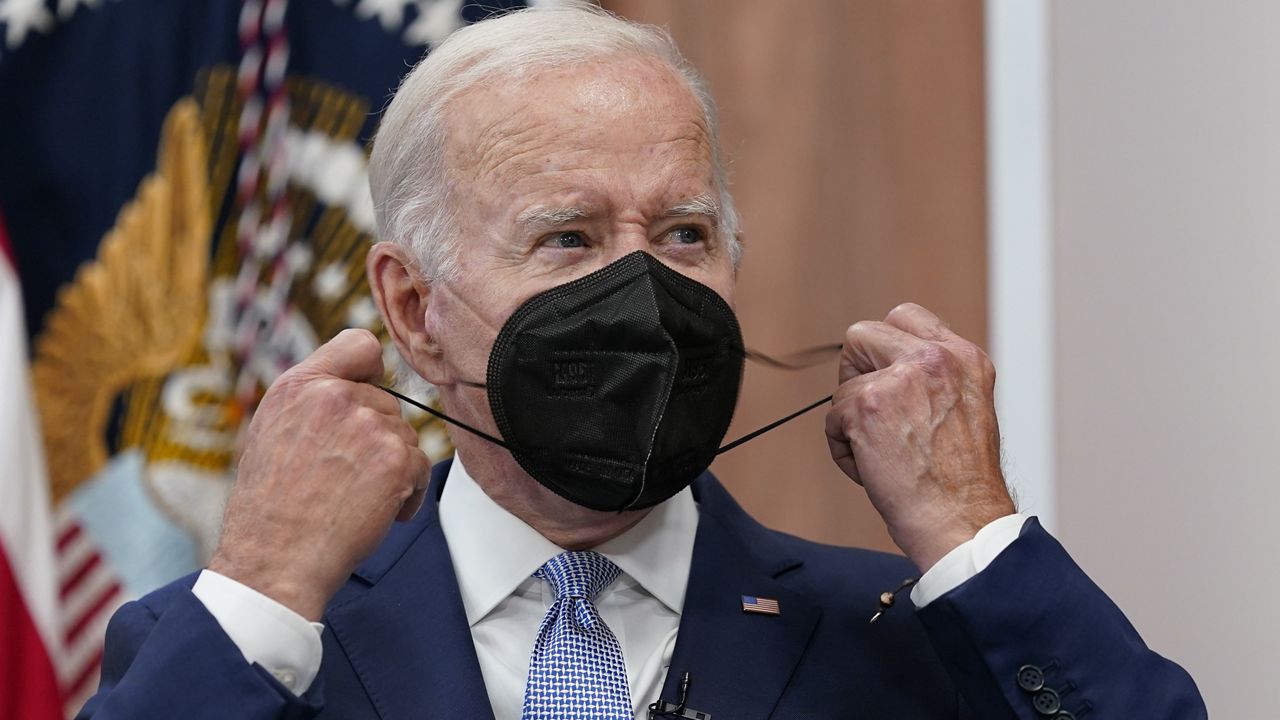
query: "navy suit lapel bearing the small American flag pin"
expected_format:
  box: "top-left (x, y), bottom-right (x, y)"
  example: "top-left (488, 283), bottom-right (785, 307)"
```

top-left (653, 474), bottom-right (822, 720)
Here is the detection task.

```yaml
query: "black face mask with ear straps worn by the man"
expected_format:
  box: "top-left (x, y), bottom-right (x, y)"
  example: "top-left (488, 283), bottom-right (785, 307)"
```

top-left (384, 251), bottom-right (838, 510)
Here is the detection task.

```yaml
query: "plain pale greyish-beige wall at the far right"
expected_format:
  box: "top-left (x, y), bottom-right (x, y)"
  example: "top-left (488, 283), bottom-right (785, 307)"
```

top-left (1051, 0), bottom-right (1280, 719)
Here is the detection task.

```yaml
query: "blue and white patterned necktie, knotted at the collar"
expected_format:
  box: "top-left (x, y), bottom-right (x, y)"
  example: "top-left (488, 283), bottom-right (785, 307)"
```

top-left (521, 551), bottom-right (634, 720)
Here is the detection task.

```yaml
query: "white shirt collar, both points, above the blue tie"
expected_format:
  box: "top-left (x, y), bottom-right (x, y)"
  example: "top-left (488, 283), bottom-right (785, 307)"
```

top-left (440, 457), bottom-right (698, 626)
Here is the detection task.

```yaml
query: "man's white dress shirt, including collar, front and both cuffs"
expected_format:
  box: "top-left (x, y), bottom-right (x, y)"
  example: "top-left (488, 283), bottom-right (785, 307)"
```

top-left (192, 459), bottom-right (1028, 707)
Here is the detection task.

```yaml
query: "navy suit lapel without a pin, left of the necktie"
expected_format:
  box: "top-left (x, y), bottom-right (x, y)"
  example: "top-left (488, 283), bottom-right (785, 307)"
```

top-left (325, 462), bottom-right (493, 720)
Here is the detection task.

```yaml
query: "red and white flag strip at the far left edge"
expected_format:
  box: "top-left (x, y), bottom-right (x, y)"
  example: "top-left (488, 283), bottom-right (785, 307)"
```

top-left (0, 210), bottom-right (63, 720)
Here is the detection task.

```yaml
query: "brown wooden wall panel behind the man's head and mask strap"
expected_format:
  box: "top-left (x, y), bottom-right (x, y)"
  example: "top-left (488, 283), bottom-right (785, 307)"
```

top-left (604, 0), bottom-right (986, 548)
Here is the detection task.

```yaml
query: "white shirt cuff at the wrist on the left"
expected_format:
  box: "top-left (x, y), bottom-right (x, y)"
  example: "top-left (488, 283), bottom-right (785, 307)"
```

top-left (191, 570), bottom-right (324, 696)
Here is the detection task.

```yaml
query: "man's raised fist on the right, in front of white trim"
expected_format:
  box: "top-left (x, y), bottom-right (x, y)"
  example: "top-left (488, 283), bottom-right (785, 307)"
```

top-left (827, 304), bottom-right (1015, 571)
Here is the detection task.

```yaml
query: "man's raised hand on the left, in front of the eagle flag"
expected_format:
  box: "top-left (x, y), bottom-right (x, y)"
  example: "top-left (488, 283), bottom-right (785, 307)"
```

top-left (209, 329), bottom-right (431, 620)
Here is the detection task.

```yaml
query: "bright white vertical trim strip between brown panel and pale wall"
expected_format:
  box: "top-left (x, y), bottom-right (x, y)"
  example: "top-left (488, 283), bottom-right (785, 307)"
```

top-left (984, 0), bottom-right (1057, 530)
